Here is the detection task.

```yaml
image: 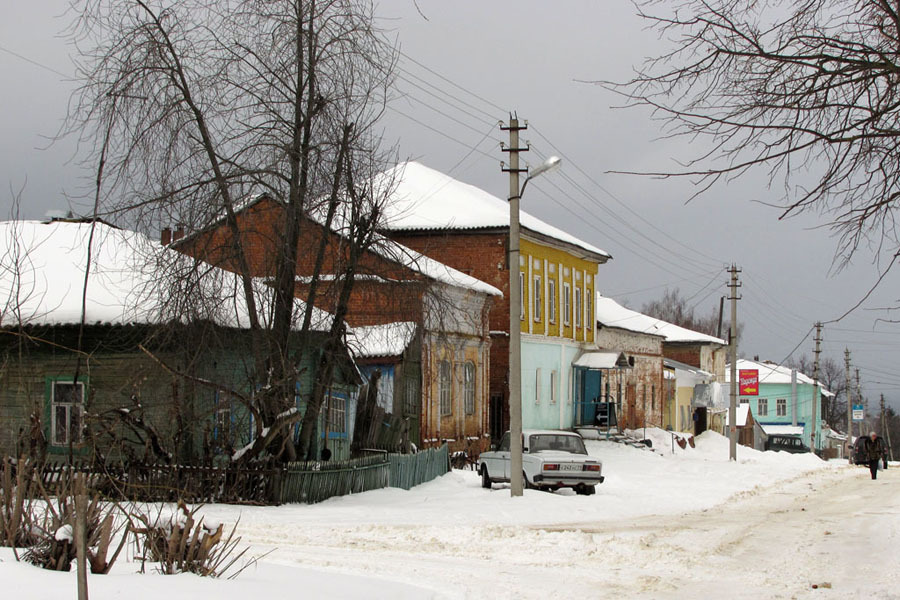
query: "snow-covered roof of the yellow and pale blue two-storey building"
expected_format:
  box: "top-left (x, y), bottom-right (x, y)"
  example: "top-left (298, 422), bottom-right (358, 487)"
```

top-left (372, 162), bottom-right (612, 262)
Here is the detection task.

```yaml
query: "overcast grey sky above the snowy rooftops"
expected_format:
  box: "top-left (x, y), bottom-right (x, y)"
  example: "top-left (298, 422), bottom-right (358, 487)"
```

top-left (0, 0), bottom-right (900, 407)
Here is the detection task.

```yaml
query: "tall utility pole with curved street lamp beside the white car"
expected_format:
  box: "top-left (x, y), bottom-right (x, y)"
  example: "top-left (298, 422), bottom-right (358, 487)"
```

top-left (509, 150), bottom-right (562, 497)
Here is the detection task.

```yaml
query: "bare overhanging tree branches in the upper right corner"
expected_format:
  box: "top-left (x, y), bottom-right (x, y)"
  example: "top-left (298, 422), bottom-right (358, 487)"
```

top-left (603, 0), bottom-right (900, 281)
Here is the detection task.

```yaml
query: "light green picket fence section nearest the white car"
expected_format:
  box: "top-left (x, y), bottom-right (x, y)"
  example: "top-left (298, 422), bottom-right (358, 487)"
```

top-left (278, 445), bottom-right (450, 504)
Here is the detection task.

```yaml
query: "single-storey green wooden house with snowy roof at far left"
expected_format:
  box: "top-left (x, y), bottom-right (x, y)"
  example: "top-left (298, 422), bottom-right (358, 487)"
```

top-left (0, 221), bottom-right (361, 463)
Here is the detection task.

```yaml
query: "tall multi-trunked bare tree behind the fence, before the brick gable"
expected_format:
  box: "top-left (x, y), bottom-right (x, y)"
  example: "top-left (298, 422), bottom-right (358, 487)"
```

top-left (70, 0), bottom-right (396, 460)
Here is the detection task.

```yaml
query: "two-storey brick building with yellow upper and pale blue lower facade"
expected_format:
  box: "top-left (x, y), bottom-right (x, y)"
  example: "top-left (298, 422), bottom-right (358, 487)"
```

top-left (372, 162), bottom-right (611, 437)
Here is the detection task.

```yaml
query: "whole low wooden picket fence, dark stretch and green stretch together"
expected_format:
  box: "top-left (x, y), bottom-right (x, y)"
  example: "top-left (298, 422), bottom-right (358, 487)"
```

top-left (14, 445), bottom-right (450, 504)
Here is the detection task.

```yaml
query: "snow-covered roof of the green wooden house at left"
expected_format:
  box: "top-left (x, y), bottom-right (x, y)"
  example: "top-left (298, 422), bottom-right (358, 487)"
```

top-left (0, 221), bottom-right (331, 329)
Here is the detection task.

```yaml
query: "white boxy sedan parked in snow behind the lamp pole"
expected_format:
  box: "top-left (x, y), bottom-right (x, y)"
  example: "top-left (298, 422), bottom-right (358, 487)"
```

top-left (478, 430), bottom-right (604, 495)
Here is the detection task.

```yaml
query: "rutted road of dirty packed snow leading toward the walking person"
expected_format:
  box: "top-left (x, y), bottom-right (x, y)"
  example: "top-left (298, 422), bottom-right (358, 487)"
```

top-left (230, 468), bottom-right (900, 598)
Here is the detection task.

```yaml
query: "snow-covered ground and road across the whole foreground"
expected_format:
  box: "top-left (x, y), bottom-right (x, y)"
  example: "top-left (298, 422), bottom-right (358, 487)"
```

top-left (0, 430), bottom-right (900, 600)
